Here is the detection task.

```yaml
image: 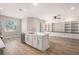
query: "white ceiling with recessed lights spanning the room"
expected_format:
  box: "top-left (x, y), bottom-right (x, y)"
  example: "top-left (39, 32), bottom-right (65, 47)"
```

top-left (0, 3), bottom-right (79, 20)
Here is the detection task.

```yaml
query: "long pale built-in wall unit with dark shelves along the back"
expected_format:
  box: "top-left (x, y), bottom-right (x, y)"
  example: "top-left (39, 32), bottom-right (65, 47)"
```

top-left (45, 20), bottom-right (79, 34)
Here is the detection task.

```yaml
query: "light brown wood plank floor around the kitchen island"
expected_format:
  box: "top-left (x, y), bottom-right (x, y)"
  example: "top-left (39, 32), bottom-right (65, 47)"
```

top-left (3, 37), bottom-right (79, 55)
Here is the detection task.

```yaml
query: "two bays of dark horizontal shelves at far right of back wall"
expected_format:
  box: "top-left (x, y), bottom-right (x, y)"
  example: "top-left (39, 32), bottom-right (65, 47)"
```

top-left (65, 21), bottom-right (79, 33)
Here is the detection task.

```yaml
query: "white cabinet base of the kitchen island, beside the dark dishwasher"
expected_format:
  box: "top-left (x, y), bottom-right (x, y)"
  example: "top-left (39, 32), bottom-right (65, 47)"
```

top-left (25, 34), bottom-right (49, 52)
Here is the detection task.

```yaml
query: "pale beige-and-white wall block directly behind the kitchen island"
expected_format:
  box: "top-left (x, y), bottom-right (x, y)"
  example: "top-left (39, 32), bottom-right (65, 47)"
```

top-left (21, 17), bottom-right (45, 33)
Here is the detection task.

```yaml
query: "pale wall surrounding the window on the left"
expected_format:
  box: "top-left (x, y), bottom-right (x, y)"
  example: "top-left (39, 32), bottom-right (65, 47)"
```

top-left (0, 15), bottom-right (21, 38)
